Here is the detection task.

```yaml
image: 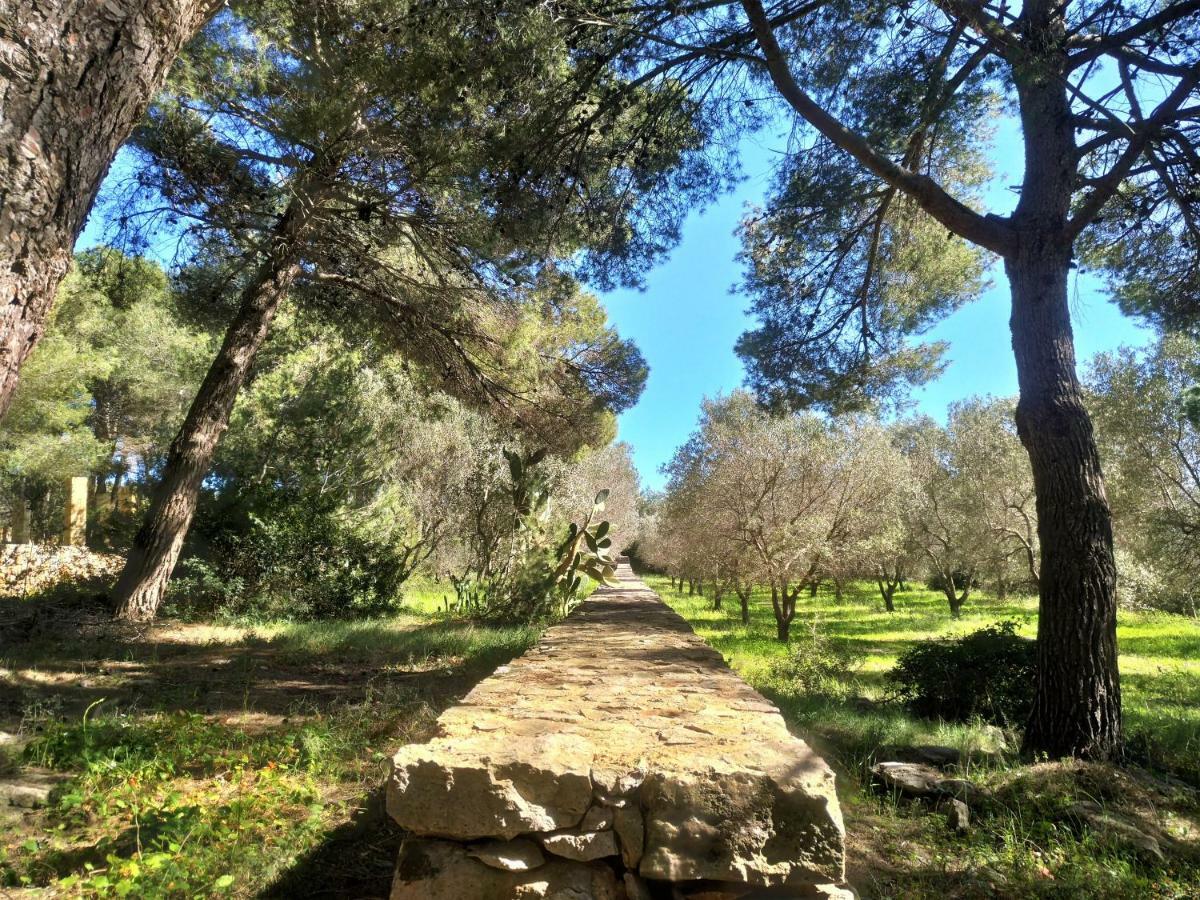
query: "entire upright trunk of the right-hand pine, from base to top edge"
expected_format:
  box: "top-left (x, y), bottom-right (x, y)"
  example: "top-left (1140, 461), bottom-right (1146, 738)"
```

top-left (1004, 44), bottom-right (1121, 758)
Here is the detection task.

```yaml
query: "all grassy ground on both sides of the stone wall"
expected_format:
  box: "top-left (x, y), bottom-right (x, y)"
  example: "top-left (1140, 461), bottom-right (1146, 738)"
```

top-left (0, 578), bottom-right (1200, 899)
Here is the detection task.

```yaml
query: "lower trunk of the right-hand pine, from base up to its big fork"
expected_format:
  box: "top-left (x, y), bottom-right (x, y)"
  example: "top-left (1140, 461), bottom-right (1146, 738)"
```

top-left (1007, 247), bottom-right (1121, 758)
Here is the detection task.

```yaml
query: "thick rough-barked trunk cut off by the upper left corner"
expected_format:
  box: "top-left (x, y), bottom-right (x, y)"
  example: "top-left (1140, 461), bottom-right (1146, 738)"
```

top-left (0, 0), bottom-right (220, 418)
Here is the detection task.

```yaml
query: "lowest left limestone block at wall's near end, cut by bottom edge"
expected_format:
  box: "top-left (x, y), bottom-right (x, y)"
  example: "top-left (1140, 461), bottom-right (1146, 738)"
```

top-left (391, 838), bottom-right (620, 900)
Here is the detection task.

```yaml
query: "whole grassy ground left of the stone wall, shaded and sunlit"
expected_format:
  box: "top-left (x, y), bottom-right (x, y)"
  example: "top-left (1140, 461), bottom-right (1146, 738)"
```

top-left (0, 584), bottom-right (538, 898)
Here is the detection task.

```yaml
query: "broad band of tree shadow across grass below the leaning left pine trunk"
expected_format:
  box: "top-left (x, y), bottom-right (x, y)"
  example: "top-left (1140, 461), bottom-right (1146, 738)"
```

top-left (0, 592), bottom-right (536, 731)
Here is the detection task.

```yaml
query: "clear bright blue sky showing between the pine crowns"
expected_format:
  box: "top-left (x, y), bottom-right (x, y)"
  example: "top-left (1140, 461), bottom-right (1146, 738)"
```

top-left (604, 121), bottom-right (1150, 488)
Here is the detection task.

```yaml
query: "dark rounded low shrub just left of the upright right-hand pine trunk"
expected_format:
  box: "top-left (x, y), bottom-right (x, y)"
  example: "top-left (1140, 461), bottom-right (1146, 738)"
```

top-left (887, 620), bottom-right (1037, 726)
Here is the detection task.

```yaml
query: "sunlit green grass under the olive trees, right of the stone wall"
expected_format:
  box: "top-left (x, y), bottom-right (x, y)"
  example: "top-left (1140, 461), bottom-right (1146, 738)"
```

top-left (647, 576), bottom-right (1200, 900)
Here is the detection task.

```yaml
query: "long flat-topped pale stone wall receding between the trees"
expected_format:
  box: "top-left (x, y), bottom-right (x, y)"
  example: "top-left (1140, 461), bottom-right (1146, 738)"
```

top-left (388, 565), bottom-right (844, 889)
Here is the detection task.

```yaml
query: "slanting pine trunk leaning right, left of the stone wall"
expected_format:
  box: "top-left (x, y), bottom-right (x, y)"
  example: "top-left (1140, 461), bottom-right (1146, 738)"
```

top-left (114, 199), bottom-right (311, 622)
